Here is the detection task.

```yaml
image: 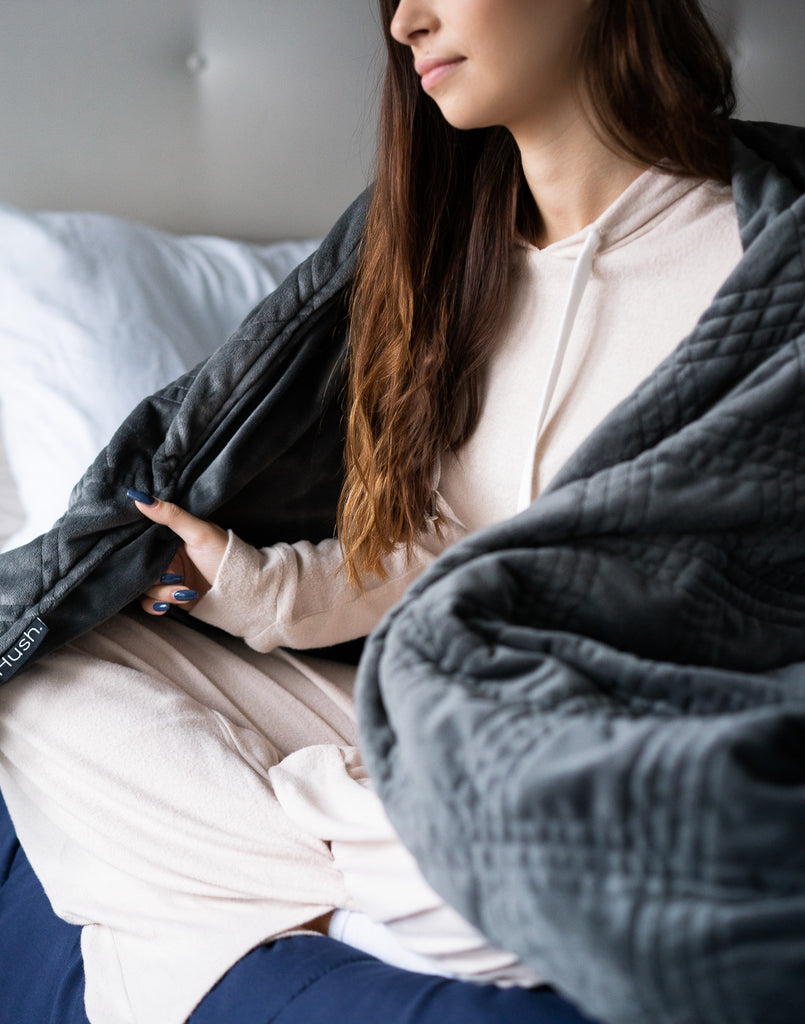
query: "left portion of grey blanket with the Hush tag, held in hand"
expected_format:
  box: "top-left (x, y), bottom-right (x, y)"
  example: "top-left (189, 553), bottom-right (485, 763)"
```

top-left (0, 189), bottom-right (370, 683)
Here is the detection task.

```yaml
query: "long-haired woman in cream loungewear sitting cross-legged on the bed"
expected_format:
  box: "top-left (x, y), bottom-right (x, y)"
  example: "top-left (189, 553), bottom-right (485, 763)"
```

top-left (0, 0), bottom-right (794, 1024)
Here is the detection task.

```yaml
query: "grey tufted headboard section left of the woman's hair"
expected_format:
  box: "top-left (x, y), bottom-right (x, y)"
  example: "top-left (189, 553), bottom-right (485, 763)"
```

top-left (0, 0), bottom-right (380, 242)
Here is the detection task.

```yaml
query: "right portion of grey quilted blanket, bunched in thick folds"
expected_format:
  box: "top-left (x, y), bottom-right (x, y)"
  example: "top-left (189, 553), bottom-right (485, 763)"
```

top-left (358, 125), bottom-right (805, 1024)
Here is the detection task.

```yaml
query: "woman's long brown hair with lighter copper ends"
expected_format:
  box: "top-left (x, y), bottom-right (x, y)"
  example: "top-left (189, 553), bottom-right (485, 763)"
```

top-left (338, 0), bottom-right (735, 582)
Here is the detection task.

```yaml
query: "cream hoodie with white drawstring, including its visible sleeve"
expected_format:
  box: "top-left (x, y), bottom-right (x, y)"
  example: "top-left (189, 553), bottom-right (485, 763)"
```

top-left (194, 166), bottom-right (743, 651)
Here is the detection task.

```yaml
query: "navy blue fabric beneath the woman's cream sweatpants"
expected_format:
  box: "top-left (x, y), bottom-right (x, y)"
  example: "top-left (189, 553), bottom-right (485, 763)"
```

top-left (0, 800), bottom-right (587, 1024)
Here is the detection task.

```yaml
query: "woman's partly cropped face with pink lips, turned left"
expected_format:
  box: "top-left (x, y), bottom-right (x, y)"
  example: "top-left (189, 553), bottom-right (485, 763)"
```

top-left (391, 0), bottom-right (594, 136)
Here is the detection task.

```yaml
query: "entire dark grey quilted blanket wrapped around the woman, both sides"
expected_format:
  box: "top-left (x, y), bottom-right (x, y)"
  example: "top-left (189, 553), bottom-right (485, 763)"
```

top-left (0, 123), bottom-right (805, 1024)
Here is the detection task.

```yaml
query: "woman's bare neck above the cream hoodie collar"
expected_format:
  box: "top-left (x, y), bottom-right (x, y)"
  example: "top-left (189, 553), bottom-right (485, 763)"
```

top-left (512, 115), bottom-right (647, 248)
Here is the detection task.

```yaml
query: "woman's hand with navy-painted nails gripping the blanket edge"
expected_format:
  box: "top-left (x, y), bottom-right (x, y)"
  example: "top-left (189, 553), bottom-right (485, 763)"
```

top-left (128, 490), bottom-right (228, 615)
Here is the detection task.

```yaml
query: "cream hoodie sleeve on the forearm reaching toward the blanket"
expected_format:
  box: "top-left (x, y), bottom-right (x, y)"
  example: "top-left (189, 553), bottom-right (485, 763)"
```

top-left (192, 499), bottom-right (466, 651)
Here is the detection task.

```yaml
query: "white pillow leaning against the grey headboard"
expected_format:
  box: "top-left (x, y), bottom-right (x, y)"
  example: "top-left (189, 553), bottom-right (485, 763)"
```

top-left (0, 204), bottom-right (317, 549)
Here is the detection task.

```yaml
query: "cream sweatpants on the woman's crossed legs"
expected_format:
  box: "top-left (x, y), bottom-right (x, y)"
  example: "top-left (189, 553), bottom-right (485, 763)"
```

top-left (0, 612), bottom-right (540, 1024)
